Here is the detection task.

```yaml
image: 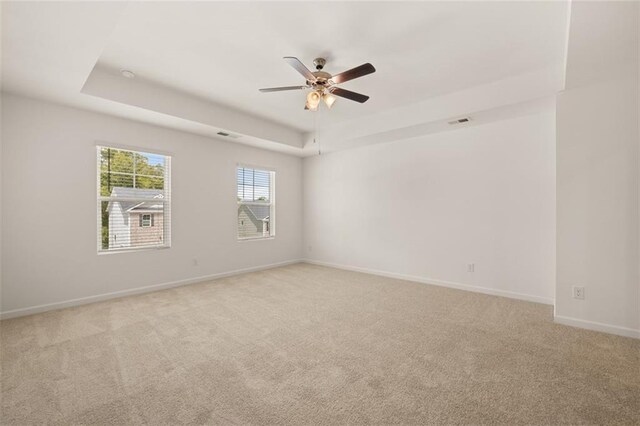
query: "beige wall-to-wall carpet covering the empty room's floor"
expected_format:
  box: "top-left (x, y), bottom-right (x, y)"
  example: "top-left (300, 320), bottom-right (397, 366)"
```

top-left (1, 264), bottom-right (640, 425)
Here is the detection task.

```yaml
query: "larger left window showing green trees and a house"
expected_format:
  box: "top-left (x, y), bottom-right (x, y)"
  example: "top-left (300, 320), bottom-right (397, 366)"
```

top-left (97, 146), bottom-right (171, 252)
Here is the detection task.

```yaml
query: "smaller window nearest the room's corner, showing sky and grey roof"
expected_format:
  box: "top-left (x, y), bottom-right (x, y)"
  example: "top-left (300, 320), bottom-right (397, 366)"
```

top-left (236, 166), bottom-right (275, 240)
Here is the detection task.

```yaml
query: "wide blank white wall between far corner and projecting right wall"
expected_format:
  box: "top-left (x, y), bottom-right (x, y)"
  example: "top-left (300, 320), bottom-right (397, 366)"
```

top-left (303, 110), bottom-right (555, 303)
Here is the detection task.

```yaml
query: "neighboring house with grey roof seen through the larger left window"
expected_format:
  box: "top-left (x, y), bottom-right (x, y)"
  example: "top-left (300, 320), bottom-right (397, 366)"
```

top-left (108, 187), bottom-right (164, 248)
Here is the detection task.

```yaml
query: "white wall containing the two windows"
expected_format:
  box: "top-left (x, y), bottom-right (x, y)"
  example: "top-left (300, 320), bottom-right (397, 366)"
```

top-left (2, 95), bottom-right (302, 316)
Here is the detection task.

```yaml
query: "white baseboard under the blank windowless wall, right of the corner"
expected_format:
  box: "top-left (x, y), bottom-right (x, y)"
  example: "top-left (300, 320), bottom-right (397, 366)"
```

top-left (303, 259), bottom-right (555, 305)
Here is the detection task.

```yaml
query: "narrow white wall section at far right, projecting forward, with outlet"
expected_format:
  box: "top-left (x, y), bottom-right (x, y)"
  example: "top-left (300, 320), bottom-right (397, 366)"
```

top-left (556, 2), bottom-right (640, 337)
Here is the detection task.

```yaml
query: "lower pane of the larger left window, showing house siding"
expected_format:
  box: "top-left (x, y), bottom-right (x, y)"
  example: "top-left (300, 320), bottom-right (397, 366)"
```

top-left (100, 201), bottom-right (169, 250)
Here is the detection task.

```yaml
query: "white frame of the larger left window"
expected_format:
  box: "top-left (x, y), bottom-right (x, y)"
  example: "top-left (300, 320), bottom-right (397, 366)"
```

top-left (95, 145), bottom-right (172, 255)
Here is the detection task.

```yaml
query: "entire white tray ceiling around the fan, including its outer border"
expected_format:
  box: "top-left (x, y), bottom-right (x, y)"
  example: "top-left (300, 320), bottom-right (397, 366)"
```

top-left (2, 1), bottom-right (568, 155)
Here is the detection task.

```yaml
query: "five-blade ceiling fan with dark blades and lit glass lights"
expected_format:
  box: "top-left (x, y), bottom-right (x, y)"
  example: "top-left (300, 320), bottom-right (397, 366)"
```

top-left (260, 56), bottom-right (376, 111)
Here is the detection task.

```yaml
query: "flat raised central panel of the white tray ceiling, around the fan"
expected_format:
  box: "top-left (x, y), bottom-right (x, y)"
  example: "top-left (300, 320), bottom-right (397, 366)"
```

top-left (99, 2), bottom-right (567, 131)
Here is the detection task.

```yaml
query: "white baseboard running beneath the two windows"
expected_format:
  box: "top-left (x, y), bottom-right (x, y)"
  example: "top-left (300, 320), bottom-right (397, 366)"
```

top-left (0, 259), bottom-right (303, 319)
